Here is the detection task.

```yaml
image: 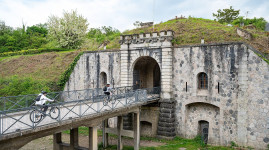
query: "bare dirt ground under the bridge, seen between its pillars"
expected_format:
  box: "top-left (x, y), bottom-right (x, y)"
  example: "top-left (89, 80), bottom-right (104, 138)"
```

top-left (20, 134), bottom-right (165, 150)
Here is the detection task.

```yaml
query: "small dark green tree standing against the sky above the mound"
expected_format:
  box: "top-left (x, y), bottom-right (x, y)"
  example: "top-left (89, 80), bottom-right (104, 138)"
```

top-left (213, 6), bottom-right (240, 23)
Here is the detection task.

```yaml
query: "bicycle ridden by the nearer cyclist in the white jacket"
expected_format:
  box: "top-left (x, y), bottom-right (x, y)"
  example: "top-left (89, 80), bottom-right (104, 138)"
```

top-left (30, 105), bottom-right (60, 123)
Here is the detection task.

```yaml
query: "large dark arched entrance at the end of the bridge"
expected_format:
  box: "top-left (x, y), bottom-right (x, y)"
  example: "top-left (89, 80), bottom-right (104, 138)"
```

top-left (133, 56), bottom-right (161, 89)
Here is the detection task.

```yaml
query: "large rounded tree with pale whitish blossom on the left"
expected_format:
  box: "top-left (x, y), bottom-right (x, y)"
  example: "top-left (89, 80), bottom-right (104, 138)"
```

top-left (48, 10), bottom-right (88, 49)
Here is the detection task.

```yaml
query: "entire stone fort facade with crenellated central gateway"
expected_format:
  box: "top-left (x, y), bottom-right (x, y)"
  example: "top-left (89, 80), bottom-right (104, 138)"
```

top-left (65, 30), bottom-right (269, 149)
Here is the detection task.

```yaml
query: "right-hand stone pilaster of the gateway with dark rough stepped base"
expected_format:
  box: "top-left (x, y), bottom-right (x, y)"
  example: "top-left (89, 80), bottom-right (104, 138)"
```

top-left (157, 31), bottom-right (176, 139)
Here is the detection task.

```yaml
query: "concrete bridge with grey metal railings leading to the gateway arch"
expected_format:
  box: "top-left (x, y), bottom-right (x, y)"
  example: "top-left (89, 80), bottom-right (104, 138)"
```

top-left (0, 86), bottom-right (160, 150)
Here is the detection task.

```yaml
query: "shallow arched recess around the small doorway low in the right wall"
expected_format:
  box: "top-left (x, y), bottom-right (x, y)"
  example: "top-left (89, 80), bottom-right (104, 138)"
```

top-left (185, 102), bottom-right (220, 145)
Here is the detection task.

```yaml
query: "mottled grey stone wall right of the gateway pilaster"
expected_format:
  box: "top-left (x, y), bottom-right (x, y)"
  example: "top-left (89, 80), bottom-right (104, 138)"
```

top-left (173, 43), bottom-right (269, 148)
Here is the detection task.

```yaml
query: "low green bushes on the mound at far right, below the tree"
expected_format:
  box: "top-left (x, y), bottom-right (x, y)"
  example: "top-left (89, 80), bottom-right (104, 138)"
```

top-left (232, 16), bottom-right (266, 30)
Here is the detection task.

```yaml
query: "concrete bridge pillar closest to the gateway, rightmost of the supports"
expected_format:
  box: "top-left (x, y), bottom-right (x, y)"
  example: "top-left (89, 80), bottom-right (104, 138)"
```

top-left (134, 112), bottom-right (140, 150)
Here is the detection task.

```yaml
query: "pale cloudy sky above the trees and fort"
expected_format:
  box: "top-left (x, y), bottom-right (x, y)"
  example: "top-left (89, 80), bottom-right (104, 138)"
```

top-left (0, 0), bottom-right (269, 31)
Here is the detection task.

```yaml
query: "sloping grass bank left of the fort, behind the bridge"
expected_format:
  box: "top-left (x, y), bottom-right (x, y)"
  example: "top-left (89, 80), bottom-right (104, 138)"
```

top-left (0, 51), bottom-right (79, 96)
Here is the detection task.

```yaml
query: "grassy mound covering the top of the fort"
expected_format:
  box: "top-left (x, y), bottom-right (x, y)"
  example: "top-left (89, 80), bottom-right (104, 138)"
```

top-left (124, 17), bottom-right (269, 54)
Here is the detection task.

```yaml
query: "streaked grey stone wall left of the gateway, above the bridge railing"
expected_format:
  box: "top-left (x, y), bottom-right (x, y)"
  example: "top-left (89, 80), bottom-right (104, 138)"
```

top-left (64, 50), bottom-right (120, 91)
